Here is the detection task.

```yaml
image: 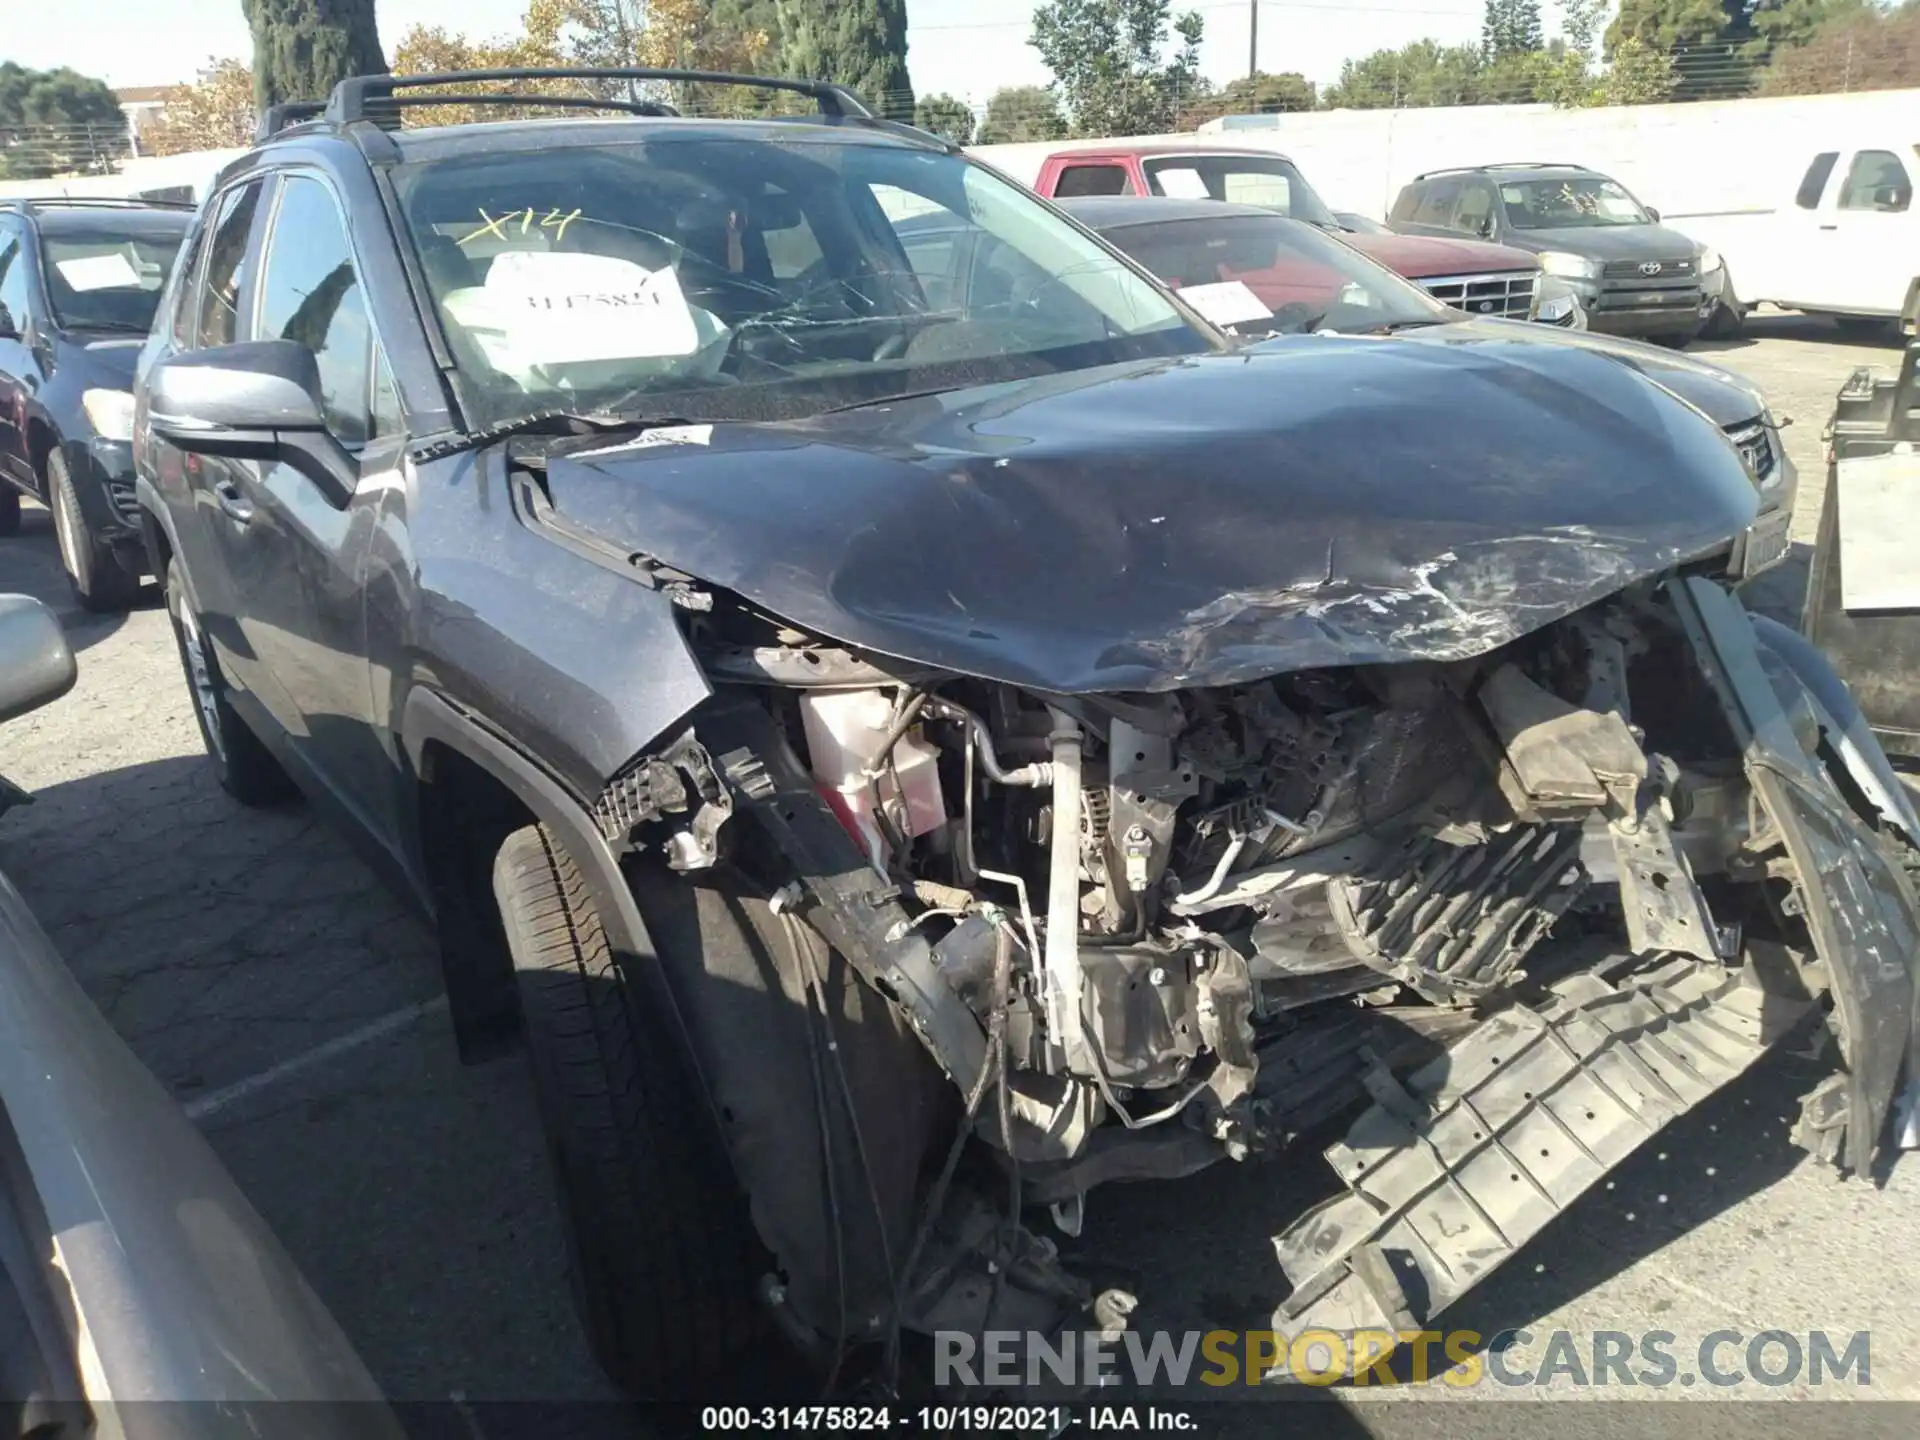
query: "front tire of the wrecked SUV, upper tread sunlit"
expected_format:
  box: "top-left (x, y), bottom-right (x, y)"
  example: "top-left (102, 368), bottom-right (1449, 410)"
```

top-left (493, 826), bottom-right (770, 1400)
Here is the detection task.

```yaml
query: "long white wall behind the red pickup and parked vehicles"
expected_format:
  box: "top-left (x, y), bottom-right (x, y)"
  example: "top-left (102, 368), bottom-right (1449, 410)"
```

top-left (973, 90), bottom-right (1920, 228)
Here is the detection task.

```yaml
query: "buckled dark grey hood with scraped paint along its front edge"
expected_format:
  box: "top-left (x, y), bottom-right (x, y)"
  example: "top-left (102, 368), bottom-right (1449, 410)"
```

top-left (547, 336), bottom-right (1755, 693)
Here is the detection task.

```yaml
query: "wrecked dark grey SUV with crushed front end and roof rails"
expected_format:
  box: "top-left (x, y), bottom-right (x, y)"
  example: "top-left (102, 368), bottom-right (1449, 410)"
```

top-left (136, 71), bottom-right (1920, 1400)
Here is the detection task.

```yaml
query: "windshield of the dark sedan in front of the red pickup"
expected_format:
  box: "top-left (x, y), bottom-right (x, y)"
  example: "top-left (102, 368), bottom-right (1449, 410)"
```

top-left (1108, 215), bottom-right (1459, 334)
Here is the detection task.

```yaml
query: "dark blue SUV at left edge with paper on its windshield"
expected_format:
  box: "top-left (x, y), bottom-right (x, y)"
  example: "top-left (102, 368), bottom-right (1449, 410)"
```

top-left (0, 198), bottom-right (192, 611)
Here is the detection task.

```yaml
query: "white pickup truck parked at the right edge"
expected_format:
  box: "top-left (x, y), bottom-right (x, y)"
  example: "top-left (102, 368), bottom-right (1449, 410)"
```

top-left (1667, 138), bottom-right (1920, 332)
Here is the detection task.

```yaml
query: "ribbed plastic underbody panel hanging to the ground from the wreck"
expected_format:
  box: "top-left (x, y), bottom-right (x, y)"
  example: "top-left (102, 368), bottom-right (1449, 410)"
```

top-left (1273, 958), bottom-right (1805, 1356)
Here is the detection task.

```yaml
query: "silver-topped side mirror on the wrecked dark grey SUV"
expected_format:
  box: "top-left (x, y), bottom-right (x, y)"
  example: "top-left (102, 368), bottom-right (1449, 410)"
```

top-left (146, 340), bottom-right (359, 509)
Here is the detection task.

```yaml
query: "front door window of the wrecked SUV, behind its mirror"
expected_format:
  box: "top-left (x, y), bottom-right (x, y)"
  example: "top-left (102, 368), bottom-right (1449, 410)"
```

top-left (255, 175), bottom-right (372, 447)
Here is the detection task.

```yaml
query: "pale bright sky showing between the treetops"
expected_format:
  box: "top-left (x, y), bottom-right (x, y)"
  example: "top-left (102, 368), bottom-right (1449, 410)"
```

top-left (0, 0), bottom-right (1557, 102)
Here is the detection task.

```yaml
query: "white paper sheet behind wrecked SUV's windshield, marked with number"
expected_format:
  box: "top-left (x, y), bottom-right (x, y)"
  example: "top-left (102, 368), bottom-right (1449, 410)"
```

top-left (444, 252), bottom-right (701, 372)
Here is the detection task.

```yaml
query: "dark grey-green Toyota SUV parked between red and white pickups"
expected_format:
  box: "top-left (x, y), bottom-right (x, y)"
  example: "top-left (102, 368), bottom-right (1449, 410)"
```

top-left (1386, 163), bottom-right (1724, 346)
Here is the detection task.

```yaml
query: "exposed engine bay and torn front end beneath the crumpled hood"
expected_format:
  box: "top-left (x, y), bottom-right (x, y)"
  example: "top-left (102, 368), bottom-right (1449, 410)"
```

top-left (599, 582), bottom-right (1914, 1390)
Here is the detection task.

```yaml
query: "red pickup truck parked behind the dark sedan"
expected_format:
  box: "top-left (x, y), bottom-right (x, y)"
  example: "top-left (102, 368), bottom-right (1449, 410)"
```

top-left (1021, 140), bottom-right (1578, 324)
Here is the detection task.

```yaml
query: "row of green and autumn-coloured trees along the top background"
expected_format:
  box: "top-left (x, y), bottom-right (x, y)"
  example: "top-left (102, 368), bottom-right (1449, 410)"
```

top-left (11, 0), bottom-right (1920, 177)
